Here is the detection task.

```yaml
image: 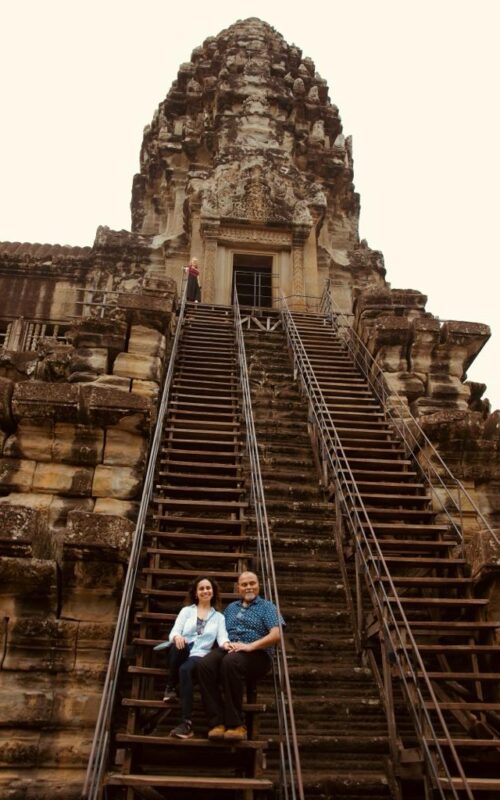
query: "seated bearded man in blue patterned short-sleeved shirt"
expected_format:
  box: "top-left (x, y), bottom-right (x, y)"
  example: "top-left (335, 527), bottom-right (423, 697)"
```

top-left (198, 572), bottom-right (284, 741)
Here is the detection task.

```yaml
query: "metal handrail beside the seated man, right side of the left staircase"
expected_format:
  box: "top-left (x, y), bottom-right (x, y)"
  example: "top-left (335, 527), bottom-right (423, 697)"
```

top-left (234, 289), bottom-right (304, 800)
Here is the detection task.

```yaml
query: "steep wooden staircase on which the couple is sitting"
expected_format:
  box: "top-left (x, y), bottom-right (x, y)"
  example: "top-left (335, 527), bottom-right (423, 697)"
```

top-left (103, 304), bottom-right (272, 800)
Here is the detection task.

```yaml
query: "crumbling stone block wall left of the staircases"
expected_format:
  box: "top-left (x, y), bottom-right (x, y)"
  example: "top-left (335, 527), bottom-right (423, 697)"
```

top-left (0, 229), bottom-right (176, 800)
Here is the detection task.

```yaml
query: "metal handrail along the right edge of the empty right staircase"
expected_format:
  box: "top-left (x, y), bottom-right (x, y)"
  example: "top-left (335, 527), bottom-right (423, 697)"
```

top-left (320, 279), bottom-right (500, 547)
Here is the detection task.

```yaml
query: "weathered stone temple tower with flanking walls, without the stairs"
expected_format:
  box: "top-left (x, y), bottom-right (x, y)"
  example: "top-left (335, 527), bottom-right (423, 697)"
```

top-left (0, 19), bottom-right (500, 800)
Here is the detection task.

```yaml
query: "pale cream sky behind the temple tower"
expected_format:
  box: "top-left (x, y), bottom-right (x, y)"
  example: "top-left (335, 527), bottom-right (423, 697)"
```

top-left (0, 0), bottom-right (500, 408)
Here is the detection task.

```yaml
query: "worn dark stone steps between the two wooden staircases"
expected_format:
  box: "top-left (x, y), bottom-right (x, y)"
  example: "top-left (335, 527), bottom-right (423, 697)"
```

top-left (245, 324), bottom-right (390, 800)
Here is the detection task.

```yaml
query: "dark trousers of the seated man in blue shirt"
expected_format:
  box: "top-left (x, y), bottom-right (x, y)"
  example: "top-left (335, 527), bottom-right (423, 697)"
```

top-left (198, 647), bottom-right (271, 728)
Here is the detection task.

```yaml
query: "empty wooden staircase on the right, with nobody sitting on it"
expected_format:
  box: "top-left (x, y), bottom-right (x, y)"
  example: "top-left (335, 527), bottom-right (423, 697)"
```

top-left (293, 313), bottom-right (500, 800)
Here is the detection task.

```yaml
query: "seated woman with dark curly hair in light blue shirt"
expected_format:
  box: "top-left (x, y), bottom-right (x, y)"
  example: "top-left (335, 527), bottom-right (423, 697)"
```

top-left (163, 576), bottom-right (229, 739)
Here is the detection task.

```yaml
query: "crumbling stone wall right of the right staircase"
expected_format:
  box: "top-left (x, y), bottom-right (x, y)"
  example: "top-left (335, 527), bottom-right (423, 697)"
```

top-left (353, 288), bottom-right (500, 608)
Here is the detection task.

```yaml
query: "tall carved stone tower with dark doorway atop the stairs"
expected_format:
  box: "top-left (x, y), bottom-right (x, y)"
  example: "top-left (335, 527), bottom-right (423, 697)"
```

top-left (132, 19), bottom-right (384, 308)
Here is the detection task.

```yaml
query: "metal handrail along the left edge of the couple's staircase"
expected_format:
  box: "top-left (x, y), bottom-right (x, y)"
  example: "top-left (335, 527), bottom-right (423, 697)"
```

top-left (81, 281), bottom-right (187, 800)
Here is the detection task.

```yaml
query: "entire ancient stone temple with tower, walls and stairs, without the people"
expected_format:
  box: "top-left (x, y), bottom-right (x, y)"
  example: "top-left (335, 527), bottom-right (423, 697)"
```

top-left (0, 19), bottom-right (500, 800)
